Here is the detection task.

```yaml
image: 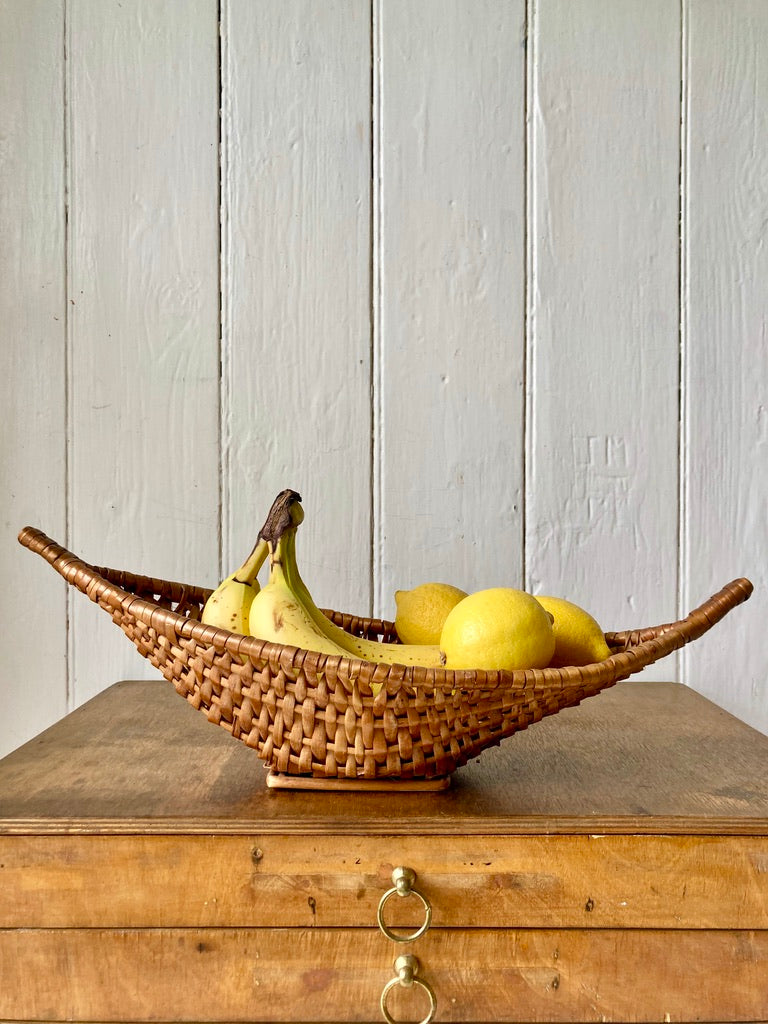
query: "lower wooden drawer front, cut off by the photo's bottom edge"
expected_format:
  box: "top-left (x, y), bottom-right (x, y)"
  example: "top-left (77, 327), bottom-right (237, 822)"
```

top-left (0, 928), bottom-right (768, 1022)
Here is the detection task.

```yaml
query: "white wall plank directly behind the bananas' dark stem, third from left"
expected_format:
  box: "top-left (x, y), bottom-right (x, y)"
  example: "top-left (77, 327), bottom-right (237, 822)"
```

top-left (222, 0), bottom-right (371, 612)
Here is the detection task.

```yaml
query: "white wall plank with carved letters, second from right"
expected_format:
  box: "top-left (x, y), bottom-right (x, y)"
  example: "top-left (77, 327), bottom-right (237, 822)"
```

top-left (526, 0), bottom-right (680, 678)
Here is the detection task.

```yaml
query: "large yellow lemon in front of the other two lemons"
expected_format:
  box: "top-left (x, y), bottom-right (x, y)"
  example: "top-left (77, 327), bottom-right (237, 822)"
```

top-left (440, 587), bottom-right (555, 671)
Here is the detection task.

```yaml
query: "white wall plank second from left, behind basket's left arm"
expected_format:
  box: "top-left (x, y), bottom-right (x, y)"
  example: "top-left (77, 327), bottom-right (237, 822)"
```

top-left (69, 0), bottom-right (219, 702)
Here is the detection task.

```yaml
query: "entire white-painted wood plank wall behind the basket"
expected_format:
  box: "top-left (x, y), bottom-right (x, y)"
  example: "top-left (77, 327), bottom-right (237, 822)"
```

top-left (0, 0), bottom-right (768, 755)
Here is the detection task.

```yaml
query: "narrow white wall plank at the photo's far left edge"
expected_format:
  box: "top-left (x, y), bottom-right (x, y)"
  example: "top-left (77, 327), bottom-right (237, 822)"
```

top-left (0, 0), bottom-right (67, 757)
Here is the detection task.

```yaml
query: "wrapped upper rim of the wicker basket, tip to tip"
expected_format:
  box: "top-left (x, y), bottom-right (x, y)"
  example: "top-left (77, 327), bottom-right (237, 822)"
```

top-left (18, 526), bottom-right (753, 692)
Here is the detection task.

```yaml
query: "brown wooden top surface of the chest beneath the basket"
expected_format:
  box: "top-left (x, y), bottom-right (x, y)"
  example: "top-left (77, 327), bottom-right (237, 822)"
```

top-left (0, 680), bottom-right (768, 835)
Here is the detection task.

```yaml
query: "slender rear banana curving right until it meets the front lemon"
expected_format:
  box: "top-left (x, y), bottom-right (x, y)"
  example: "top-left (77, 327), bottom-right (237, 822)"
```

top-left (268, 492), bottom-right (441, 668)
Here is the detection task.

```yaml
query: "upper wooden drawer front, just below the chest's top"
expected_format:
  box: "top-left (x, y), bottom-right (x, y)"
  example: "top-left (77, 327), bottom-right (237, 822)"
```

top-left (0, 835), bottom-right (768, 930)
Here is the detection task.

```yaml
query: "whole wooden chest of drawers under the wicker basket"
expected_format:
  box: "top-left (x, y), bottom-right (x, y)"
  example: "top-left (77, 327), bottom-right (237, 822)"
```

top-left (0, 681), bottom-right (768, 1022)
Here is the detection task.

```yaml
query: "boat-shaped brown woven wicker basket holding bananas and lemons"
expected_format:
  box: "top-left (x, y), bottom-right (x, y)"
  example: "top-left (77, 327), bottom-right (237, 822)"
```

top-left (18, 526), bottom-right (753, 791)
